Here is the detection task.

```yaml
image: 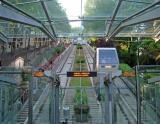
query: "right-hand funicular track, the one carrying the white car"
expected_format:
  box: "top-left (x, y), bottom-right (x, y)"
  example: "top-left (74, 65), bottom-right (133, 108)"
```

top-left (85, 45), bottom-right (137, 124)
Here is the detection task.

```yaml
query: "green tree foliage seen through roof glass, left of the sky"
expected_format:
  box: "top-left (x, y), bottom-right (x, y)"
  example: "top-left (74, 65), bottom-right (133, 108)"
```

top-left (6, 0), bottom-right (71, 32)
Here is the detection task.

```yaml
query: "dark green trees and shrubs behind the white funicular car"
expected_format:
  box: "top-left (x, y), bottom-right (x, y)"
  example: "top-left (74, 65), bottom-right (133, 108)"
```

top-left (117, 38), bottom-right (160, 66)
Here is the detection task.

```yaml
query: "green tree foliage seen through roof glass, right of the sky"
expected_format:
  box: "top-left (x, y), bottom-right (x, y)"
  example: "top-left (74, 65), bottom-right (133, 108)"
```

top-left (83, 0), bottom-right (153, 33)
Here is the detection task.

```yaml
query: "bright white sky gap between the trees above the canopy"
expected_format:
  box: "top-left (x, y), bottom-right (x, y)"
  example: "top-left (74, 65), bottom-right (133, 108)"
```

top-left (58, 0), bottom-right (86, 27)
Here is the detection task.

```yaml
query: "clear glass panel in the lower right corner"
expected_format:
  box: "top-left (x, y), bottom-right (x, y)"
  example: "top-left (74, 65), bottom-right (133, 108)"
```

top-left (139, 65), bottom-right (160, 124)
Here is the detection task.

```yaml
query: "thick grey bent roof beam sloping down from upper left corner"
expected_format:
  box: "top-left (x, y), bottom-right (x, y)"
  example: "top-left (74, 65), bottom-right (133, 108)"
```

top-left (0, 0), bottom-right (55, 40)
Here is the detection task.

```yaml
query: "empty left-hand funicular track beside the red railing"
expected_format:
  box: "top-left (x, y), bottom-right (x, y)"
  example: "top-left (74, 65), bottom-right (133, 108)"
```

top-left (17, 45), bottom-right (74, 124)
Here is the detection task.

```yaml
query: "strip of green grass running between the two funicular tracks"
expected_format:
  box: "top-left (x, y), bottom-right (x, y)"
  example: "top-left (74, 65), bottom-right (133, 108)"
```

top-left (70, 49), bottom-right (91, 86)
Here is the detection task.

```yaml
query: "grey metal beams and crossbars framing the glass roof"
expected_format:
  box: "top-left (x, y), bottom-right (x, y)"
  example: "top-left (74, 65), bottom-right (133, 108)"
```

top-left (0, 0), bottom-right (160, 41)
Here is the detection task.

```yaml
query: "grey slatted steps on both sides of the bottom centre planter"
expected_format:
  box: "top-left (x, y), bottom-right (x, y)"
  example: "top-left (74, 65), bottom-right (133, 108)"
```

top-left (60, 88), bottom-right (103, 124)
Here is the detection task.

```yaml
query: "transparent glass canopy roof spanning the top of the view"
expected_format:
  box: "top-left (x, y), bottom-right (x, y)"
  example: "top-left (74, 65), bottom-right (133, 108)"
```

top-left (0, 0), bottom-right (160, 40)
